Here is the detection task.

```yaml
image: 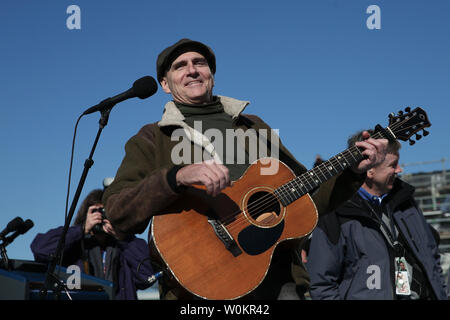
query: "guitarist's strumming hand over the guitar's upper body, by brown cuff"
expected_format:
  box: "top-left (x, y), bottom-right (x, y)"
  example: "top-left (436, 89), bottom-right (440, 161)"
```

top-left (176, 160), bottom-right (231, 197)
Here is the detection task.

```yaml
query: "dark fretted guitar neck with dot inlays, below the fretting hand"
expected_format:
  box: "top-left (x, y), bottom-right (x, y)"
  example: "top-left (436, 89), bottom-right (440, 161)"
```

top-left (275, 132), bottom-right (383, 206)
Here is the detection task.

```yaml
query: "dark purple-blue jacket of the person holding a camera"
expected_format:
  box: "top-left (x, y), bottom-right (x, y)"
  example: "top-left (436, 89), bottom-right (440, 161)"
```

top-left (31, 225), bottom-right (153, 300)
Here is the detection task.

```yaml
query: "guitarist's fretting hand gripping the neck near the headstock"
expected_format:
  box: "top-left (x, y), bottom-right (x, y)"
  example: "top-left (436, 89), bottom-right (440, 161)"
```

top-left (352, 131), bottom-right (388, 174)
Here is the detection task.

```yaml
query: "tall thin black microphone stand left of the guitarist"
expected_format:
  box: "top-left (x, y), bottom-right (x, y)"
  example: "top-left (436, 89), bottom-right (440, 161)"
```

top-left (39, 106), bottom-right (115, 300)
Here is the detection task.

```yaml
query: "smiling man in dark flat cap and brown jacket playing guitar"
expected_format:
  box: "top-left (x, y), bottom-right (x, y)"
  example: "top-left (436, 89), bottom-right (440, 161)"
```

top-left (103, 39), bottom-right (387, 299)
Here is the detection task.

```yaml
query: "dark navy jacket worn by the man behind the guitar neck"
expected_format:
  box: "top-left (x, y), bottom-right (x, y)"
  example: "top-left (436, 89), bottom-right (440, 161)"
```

top-left (307, 179), bottom-right (447, 300)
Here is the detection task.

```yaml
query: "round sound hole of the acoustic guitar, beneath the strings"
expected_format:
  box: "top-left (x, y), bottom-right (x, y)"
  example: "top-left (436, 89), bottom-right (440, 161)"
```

top-left (247, 192), bottom-right (281, 225)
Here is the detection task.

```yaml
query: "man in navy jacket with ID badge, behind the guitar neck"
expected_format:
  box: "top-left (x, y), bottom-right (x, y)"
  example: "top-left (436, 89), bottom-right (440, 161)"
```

top-left (307, 130), bottom-right (447, 300)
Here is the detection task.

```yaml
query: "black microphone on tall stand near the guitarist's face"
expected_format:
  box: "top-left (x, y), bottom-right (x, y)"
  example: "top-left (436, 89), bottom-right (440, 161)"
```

top-left (83, 76), bottom-right (158, 115)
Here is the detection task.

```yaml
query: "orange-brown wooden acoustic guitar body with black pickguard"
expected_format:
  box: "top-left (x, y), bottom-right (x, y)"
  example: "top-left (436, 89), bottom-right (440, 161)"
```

top-left (151, 158), bottom-right (318, 299)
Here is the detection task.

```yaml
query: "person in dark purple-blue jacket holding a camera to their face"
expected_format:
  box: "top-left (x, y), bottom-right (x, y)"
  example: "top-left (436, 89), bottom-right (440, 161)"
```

top-left (31, 189), bottom-right (153, 300)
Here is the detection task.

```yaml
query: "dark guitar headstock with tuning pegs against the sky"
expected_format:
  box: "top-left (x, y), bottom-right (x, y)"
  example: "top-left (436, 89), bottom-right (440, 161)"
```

top-left (388, 107), bottom-right (431, 145)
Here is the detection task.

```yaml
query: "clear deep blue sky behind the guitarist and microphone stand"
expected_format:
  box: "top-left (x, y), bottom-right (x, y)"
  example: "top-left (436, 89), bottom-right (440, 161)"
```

top-left (0, 0), bottom-right (450, 259)
